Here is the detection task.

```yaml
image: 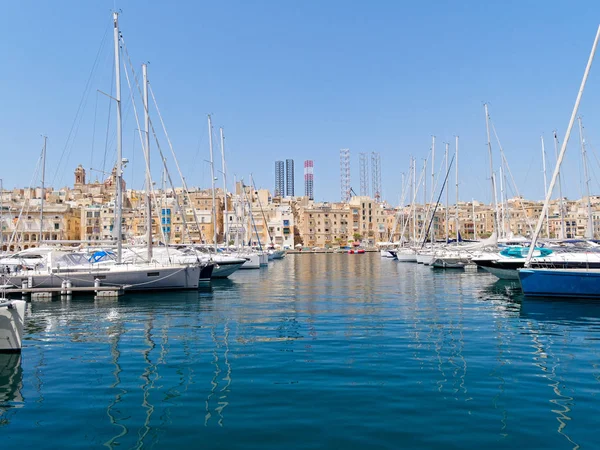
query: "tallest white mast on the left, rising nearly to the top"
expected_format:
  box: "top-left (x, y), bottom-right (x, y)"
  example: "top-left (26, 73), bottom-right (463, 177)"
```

top-left (113, 12), bottom-right (123, 264)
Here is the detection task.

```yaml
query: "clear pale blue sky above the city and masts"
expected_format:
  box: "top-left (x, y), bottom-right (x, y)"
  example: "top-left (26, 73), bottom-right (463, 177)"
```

top-left (0, 0), bottom-right (600, 204)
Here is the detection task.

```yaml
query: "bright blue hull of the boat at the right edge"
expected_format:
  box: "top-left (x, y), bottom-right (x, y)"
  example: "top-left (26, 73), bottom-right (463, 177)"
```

top-left (518, 269), bottom-right (600, 299)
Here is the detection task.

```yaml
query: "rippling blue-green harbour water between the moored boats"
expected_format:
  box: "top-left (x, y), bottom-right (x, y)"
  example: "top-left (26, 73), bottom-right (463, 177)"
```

top-left (0, 254), bottom-right (600, 449)
